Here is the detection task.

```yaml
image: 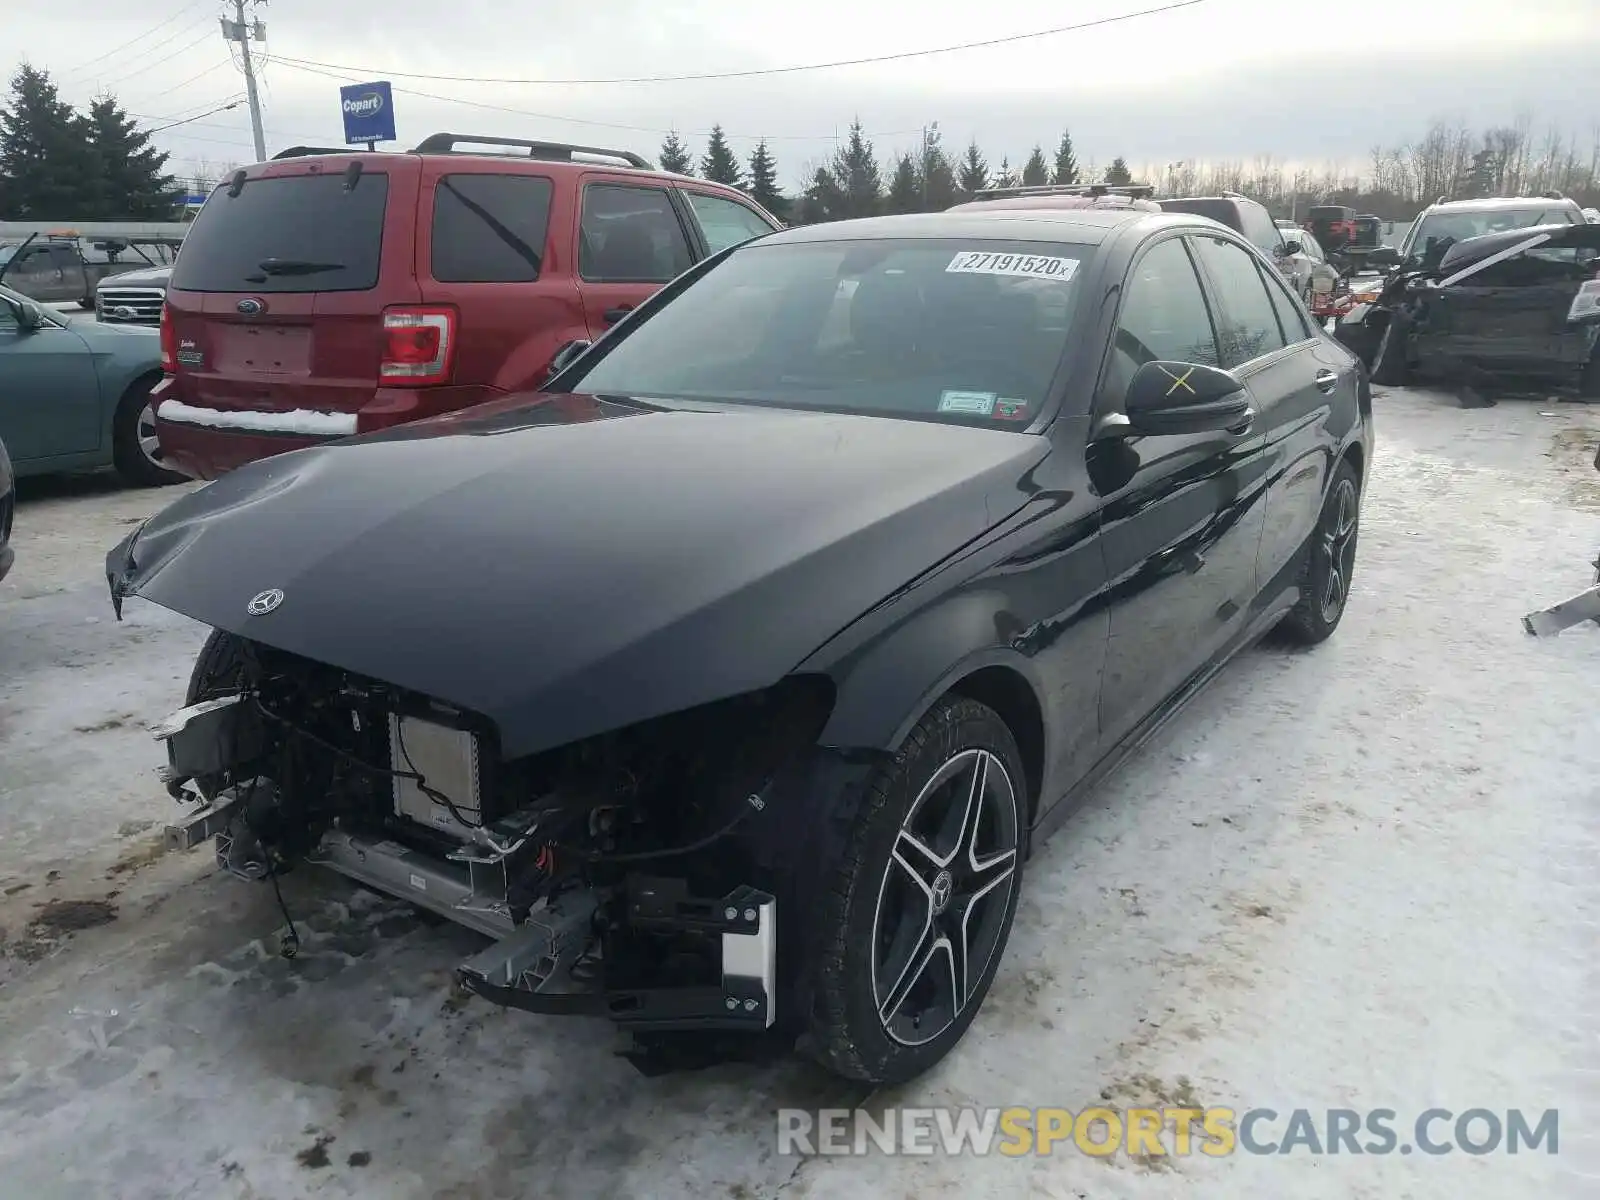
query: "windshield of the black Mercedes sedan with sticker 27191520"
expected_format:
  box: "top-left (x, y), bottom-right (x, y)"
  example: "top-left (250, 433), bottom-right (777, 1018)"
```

top-left (563, 240), bottom-right (1093, 427)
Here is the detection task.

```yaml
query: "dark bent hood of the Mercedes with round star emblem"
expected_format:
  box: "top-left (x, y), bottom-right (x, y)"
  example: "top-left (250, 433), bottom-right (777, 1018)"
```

top-left (107, 395), bottom-right (1048, 757)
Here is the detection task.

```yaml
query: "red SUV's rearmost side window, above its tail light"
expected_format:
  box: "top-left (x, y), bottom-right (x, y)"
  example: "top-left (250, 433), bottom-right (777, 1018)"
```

top-left (430, 174), bottom-right (550, 283)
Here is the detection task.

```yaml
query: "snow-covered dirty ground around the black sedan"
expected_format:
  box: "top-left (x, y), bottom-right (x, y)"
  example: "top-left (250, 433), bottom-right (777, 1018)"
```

top-left (0, 390), bottom-right (1600, 1200)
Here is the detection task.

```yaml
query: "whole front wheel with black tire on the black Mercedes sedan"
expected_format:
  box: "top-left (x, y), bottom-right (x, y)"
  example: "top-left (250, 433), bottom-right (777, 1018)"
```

top-left (802, 698), bottom-right (1029, 1085)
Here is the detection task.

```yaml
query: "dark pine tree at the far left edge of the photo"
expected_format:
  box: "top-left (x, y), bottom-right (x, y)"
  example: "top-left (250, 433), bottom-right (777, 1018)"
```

top-left (0, 62), bottom-right (101, 221)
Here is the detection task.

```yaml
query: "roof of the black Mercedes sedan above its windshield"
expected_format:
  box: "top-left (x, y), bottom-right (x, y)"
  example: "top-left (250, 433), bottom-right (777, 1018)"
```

top-left (760, 208), bottom-right (1216, 246)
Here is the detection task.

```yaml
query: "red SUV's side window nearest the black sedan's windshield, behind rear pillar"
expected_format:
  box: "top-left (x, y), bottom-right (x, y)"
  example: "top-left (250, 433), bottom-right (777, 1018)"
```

top-left (578, 184), bottom-right (693, 283)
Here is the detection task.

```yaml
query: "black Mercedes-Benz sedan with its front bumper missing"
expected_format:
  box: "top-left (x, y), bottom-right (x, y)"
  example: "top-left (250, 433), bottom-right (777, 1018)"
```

top-left (107, 208), bottom-right (1373, 1082)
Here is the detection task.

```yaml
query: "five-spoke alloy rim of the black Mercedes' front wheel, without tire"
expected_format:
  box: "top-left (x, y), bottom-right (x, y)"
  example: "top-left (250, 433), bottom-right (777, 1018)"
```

top-left (870, 749), bottom-right (1021, 1046)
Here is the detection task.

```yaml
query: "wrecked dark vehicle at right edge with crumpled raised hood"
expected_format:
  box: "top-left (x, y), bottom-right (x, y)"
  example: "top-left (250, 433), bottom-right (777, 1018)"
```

top-left (1338, 222), bottom-right (1600, 398)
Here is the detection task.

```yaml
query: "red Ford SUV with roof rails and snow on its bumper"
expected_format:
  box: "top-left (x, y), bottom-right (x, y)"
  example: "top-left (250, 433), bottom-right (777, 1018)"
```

top-left (152, 133), bottom-right (781, 478)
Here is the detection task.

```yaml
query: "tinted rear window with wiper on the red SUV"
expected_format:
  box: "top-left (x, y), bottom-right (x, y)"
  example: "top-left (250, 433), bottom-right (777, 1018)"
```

top-left (173, 171), bottom-right (389, 293)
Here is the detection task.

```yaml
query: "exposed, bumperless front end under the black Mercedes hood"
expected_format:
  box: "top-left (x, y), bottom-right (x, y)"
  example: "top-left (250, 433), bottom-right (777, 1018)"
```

top-left (157, 638), bottom-right (834, 1049)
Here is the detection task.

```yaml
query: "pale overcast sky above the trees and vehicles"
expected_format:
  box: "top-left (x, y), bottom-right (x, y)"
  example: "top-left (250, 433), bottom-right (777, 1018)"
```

top-left (12, 0), bottom-right (1600, 187)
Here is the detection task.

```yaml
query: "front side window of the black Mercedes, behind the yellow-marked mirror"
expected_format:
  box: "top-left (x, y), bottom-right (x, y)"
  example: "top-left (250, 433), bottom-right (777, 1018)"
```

top-left (1101, 237), bottom-right (1219, 405)
